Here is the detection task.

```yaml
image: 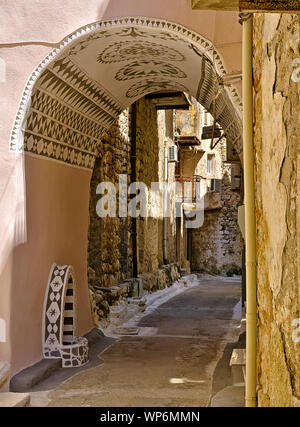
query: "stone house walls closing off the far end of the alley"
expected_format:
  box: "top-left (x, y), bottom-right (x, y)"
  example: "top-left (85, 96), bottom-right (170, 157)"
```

top-left (176, 103), bottom-right (242, 275)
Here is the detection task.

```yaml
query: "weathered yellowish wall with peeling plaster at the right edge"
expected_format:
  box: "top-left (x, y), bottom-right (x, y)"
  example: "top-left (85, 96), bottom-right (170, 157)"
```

top-left (254, 14), bottom-right (300, 406)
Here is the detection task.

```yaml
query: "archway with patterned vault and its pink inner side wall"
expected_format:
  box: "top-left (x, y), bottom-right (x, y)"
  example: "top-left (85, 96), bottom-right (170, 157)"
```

top-left (10, 18), bottom-right (241, 367)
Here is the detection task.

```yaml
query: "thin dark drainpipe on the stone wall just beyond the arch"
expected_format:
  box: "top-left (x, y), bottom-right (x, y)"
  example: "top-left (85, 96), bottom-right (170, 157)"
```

top-left (130, 102), bottom-right (138, 277)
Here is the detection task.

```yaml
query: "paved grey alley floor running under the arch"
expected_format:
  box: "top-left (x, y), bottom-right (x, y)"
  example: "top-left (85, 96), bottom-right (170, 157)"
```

top-left (31, 278), bottom-right (241, 407)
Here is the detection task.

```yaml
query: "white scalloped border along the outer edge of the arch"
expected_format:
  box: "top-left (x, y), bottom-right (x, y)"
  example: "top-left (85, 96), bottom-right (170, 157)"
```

top-left (9, 17), bottom-right (242, 152)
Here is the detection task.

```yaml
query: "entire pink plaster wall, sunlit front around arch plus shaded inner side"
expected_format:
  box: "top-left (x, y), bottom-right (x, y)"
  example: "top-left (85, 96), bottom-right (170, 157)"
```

top-left (0, 0), bottom-right (241, 373)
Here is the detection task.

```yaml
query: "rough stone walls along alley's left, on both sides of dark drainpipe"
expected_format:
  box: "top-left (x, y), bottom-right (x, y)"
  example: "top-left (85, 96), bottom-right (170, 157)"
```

top-left (88, 98), bottom-right (185, 326)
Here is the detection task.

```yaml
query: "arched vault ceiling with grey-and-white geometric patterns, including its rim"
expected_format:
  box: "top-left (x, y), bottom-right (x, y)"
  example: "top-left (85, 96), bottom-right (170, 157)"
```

top-left (11, 18), bottom-right (241, 169)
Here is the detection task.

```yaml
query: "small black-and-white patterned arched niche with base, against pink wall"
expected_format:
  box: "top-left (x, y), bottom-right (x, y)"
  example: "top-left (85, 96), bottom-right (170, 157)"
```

top-left (43, 263), bottom-right (88, 367)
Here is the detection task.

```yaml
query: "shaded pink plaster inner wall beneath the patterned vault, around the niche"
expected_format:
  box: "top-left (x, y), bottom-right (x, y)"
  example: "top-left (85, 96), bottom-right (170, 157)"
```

top-left (10, 155), bottom-right (92, 371)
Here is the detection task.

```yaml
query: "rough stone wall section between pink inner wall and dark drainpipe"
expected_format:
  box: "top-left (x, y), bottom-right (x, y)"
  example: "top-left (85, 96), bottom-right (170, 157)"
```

top-left (88, 110), bottom-right (132, 287)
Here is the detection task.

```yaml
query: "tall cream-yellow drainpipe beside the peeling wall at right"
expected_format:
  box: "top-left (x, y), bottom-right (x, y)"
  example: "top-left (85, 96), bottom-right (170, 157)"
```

top-left (240, 13), bottom-right (257, 407)
